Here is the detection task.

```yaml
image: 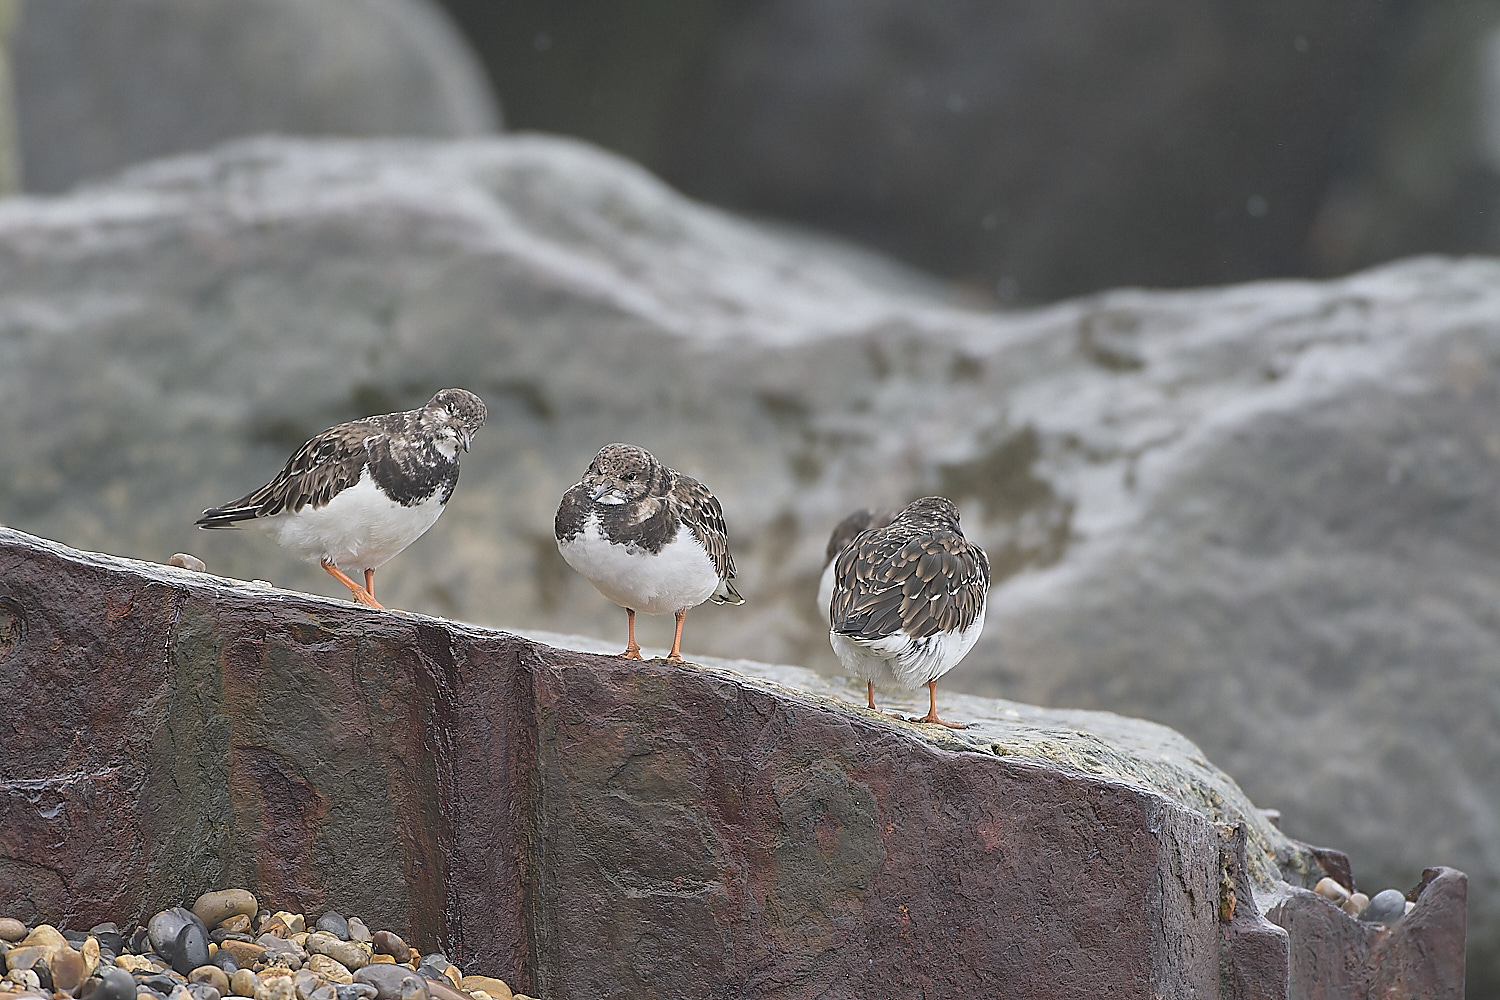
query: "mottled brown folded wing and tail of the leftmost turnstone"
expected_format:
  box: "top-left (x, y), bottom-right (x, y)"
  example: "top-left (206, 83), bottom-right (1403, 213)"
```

top-left (197, 420), bottom-right (381, 528)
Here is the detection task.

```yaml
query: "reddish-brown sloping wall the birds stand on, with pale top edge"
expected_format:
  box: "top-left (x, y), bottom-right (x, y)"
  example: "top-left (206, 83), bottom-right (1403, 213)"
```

top-left (0, 529), bottom-right (1464, 1000)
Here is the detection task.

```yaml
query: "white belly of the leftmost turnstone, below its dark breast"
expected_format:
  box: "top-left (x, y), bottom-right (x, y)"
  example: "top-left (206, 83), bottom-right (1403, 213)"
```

top-left (257, 469), bottom-right (443, 571)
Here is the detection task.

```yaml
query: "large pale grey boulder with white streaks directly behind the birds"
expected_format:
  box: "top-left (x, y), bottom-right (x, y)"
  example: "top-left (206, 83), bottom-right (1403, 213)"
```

top-left (0, 138), bottom-right (1500, 985)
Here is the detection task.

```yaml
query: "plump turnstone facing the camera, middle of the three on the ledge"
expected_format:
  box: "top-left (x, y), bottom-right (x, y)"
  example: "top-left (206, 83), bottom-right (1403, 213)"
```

top-left (555, 444), bottom-right (744, 661)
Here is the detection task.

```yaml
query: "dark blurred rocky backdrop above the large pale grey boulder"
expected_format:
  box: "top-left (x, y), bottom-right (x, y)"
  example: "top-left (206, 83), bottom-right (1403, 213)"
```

top-left (443, 0), bottom-right (1500, 301)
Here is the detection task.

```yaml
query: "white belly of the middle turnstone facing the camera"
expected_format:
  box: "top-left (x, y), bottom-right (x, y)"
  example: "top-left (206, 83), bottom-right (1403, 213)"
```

top-left (558, 514), bottom-right (719, 615)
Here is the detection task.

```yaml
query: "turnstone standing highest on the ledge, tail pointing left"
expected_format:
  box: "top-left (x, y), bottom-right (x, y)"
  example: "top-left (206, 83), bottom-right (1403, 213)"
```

top-left (195, 388), bottom-right (485, 607)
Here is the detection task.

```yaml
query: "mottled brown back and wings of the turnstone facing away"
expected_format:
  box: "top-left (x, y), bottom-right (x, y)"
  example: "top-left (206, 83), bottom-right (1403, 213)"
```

top-left (831, 531), bottom-right (990, 640)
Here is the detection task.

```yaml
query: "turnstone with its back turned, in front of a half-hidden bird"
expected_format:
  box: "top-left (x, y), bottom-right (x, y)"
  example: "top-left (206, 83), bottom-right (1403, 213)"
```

top-left (828, 496), bottom-right (990, 729)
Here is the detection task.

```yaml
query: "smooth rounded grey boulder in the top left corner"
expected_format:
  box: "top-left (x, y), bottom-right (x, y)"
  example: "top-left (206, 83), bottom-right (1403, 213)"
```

top-left (8, 0), bottom-right (500, 192)
